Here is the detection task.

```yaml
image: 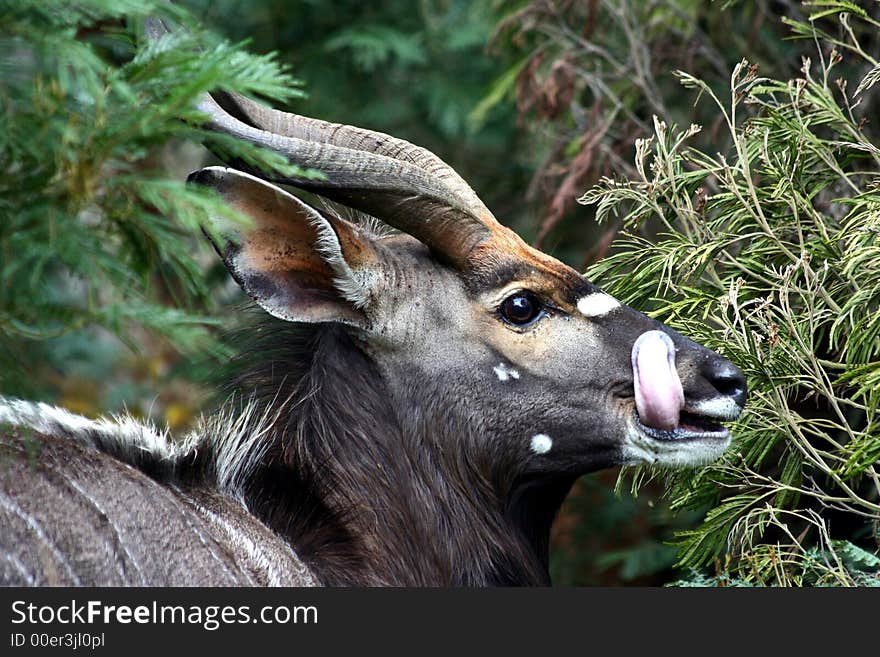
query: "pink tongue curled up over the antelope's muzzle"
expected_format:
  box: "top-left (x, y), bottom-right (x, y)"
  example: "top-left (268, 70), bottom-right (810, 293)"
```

top-left (632, 331), bottom-right (684, 429)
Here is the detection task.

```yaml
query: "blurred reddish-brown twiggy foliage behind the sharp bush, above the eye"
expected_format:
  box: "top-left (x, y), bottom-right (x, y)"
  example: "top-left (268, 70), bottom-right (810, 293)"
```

top-left (482, 0), bottom-right (812, 255)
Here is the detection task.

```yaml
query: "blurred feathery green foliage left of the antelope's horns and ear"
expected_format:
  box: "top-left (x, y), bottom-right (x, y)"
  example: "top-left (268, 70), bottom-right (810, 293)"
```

top-left (0, 0), bottom-right (306, 398)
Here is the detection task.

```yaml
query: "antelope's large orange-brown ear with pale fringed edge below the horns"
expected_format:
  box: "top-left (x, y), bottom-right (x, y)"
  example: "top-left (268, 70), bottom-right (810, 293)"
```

top-left (188, 167), bottom-right (379, 327)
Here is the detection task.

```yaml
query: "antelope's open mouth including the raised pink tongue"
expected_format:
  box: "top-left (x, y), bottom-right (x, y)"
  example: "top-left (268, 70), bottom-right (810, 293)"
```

top-left (632, 330), bottom-right (741, 442)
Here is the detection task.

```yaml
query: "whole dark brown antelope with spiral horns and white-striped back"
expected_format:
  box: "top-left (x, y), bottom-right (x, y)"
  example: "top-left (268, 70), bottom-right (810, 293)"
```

top-left (0, 24), bottom-right (746, 586)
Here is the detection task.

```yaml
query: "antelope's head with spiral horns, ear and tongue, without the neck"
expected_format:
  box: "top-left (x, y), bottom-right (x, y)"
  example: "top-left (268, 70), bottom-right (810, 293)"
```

top-left (191, 83), bottom-right (746, 479)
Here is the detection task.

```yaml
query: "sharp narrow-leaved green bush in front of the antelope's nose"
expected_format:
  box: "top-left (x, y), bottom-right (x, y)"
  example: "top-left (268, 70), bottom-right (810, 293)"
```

top-left (581, 9), bottom-right (880, 585)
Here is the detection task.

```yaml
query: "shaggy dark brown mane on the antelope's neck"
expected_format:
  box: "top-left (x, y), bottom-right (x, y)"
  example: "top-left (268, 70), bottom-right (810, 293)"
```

top-left (208, 321), bottom-right (572, 586)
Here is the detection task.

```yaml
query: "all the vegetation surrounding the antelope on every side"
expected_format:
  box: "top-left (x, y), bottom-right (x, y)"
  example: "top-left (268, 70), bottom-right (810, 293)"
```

top-left (0, 0), bottom-right (880, 585)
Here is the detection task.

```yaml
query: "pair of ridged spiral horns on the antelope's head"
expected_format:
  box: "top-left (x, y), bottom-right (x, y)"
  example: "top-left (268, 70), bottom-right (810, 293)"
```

top-left (199, 93), bottom-right (498, 268)
